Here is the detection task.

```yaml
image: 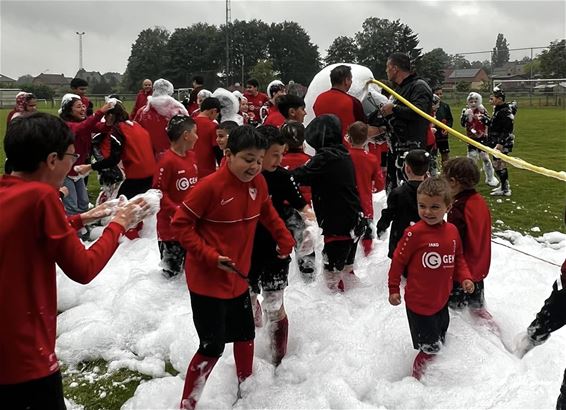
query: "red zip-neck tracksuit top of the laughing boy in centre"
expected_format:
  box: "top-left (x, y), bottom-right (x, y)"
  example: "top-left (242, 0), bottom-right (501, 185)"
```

top-left (173, 166), bottom-right (295, 299)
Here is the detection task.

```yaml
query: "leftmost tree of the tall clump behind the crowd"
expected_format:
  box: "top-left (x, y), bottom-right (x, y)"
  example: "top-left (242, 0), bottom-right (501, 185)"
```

top-left (124, 27), bottom-right (169, 92)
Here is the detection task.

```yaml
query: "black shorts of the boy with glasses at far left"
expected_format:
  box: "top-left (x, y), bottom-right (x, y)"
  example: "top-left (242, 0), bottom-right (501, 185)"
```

top-left (0, 371), bottom-right (67, 410)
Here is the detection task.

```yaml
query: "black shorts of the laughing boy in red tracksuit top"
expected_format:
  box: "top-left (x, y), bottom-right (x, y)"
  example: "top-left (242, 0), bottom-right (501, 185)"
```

top-left (190, 290), bottom-right (255, 357)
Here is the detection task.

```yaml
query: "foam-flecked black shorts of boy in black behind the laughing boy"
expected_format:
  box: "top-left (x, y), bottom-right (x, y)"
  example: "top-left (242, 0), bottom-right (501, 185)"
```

top-left (248, 257), bottom-right (291, 294)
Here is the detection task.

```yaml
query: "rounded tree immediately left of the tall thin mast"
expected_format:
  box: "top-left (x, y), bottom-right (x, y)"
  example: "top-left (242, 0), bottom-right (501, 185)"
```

top-left (164, 23), bottom-right (225, 88)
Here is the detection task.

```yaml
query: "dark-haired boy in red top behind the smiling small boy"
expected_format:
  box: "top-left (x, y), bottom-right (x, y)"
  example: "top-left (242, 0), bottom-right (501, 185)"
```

top-left (442, 157), bottom-right (496, 326)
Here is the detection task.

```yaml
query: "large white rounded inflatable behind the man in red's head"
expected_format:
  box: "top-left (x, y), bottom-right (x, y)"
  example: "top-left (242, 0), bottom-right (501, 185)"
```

top-left (304, 63), bottom-right (387, 126)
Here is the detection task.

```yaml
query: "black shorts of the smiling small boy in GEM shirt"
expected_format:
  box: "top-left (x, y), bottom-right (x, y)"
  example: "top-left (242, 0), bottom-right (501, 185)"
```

top-left (407, 304), bottom-right (450, 354)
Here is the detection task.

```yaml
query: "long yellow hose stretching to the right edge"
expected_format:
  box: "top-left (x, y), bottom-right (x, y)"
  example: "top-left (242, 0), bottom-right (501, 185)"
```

top-left (369, 80), bottom-right (566, 181)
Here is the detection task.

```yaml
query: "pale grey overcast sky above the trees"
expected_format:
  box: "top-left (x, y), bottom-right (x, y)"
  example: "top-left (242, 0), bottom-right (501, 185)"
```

top-left (0, 0), bottom-right (566, 79)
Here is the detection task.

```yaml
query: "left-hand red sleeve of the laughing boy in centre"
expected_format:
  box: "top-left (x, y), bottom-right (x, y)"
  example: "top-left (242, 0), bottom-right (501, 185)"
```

top-left (171, 184), bottom-right (220, 266)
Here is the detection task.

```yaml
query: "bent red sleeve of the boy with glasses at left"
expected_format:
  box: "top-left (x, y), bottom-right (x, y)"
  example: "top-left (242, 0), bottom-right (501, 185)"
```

top-left (42, 192), bottom-right (124, 284)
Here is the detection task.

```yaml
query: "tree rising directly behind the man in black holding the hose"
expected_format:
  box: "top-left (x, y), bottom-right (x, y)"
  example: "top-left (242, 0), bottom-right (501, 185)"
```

top-left (355, 17), bottom-right (422, 79)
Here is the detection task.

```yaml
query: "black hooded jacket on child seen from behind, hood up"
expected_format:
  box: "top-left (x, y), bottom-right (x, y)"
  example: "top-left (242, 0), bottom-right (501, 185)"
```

top-left (292, 115), bottom-right (362, 236)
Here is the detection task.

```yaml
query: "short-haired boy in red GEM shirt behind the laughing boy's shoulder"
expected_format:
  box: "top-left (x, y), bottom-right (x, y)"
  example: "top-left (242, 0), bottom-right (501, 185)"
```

top-left (153, 115), bottom-right (198, 278)
